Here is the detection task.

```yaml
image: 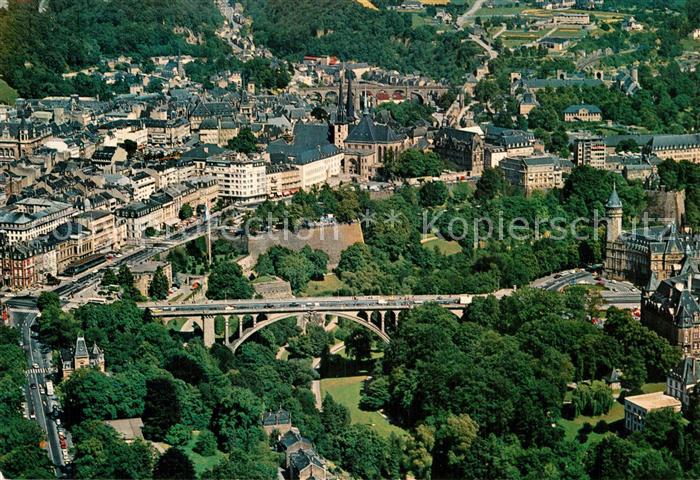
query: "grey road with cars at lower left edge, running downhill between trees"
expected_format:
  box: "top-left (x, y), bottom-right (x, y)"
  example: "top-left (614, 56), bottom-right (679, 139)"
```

top-left (12, 310), bottom-right (64, 469)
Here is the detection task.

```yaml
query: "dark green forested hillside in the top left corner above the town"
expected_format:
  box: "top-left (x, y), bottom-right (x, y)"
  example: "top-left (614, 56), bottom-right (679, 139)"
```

top-left (0, 0), bottom-right (225, 97)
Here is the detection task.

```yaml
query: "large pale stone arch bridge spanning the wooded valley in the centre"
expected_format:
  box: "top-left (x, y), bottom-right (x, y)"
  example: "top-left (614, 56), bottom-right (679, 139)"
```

top-left (143, 295), bottom-right (490, 352)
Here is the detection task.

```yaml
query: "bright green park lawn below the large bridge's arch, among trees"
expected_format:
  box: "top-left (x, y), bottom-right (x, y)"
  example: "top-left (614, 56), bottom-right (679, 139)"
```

top-left (321, 376), bottom-right (406, 438)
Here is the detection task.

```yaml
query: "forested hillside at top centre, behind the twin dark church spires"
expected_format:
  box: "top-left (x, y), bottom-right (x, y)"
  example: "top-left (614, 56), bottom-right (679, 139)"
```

top-left (238, 0), bottom-right (482, 80)
